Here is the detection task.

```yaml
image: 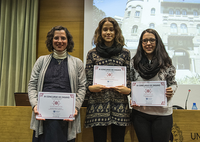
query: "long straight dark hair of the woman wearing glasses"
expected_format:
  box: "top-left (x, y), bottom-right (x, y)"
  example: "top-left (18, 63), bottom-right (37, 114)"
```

top-left (133, 29), bottom-right (172, 70)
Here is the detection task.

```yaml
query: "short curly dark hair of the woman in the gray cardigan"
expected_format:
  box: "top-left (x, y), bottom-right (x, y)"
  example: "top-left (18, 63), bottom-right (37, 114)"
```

top-left (45, 26), bottom-right (74, 52)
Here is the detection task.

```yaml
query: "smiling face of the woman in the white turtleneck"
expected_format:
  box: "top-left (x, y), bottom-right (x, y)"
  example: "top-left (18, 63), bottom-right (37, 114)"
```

top-left (53, 30), bottom-right (68, 52)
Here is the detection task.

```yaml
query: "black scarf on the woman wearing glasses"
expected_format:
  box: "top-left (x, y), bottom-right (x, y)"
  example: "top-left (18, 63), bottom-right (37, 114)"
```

top-left (138, 56), bottom-right (160, 80)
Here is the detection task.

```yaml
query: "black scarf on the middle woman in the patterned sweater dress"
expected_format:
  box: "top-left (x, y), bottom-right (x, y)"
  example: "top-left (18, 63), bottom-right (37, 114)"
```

top-left (96, 44), bottom-right (123, 58)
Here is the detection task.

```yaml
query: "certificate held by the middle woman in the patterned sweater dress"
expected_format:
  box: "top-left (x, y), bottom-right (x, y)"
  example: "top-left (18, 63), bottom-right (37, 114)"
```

top-left (93, 65), bottom-right (126, 87)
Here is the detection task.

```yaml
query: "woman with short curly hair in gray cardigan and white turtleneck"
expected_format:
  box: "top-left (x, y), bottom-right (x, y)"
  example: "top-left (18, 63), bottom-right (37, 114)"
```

top-left (28, 26), bottom-right (86, 142)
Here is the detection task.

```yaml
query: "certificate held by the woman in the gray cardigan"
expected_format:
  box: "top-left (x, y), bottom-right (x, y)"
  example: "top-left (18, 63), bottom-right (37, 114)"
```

top-left (36, 92), bottom-right (76, 120)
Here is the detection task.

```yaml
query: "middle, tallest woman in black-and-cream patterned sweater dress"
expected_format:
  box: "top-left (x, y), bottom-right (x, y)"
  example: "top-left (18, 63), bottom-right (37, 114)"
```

top-left (85, 17), bottom-right (130, 142)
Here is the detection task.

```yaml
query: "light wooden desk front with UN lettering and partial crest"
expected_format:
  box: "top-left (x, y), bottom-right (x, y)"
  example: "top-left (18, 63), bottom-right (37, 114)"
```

top-left (172, 110), bottom-right (200, 142)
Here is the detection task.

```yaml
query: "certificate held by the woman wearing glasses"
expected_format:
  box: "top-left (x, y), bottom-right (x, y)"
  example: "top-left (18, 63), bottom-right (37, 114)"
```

top-left (131, 81), bottom-right (167, 106)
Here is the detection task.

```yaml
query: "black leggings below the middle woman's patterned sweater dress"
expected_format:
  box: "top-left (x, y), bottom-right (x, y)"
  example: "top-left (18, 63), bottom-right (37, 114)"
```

top-left (93, 124), bottom-right (126, 142)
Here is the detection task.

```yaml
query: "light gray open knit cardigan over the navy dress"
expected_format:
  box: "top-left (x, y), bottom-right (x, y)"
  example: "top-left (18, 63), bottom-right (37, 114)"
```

top-left (28, 54), bottom-right (86, 140)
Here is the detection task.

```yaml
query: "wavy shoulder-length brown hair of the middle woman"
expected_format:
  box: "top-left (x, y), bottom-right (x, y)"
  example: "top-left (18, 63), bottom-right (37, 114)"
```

top-left (93, 17), bottom-right (125, 46)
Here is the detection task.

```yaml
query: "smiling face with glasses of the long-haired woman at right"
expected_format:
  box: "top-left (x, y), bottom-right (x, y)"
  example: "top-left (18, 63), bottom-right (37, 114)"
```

top-left (142, 32), bottom-right (156, 60)
